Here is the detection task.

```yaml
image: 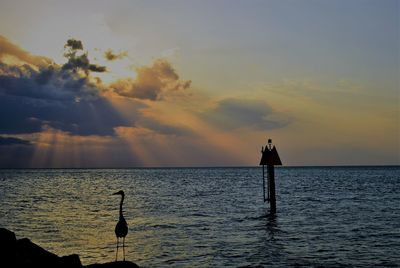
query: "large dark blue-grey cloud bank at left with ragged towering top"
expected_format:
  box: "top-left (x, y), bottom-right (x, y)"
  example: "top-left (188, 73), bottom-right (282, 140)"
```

top-left (0, 39), bottom-right (132, 135)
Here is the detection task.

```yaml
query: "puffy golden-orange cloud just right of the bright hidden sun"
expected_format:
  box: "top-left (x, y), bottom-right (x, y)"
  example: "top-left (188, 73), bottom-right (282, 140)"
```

top-left (110, 59), bottom-right (191, 101)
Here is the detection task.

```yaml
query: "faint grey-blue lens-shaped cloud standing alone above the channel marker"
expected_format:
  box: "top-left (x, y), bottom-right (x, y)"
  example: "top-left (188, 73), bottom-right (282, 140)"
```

top-left (201, 98), bottom-right (290, 130)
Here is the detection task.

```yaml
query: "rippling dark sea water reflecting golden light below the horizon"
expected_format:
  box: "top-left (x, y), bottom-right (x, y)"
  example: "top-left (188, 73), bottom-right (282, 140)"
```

top-left (0, 167), bottom-right (400, 267)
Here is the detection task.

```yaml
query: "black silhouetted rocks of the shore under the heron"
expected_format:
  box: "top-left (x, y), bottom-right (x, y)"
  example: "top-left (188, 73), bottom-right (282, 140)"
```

top-left (0, 228), bottom-right (139, 268)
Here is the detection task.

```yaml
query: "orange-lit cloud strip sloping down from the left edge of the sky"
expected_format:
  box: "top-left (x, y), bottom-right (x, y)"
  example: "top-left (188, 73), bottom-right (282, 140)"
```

top-left (0, 35), bottom-right (52, 66)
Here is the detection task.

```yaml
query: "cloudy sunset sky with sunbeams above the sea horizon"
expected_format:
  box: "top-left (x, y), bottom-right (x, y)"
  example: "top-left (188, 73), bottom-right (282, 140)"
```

top-left (0, 0), bottom-right (400, 168)
